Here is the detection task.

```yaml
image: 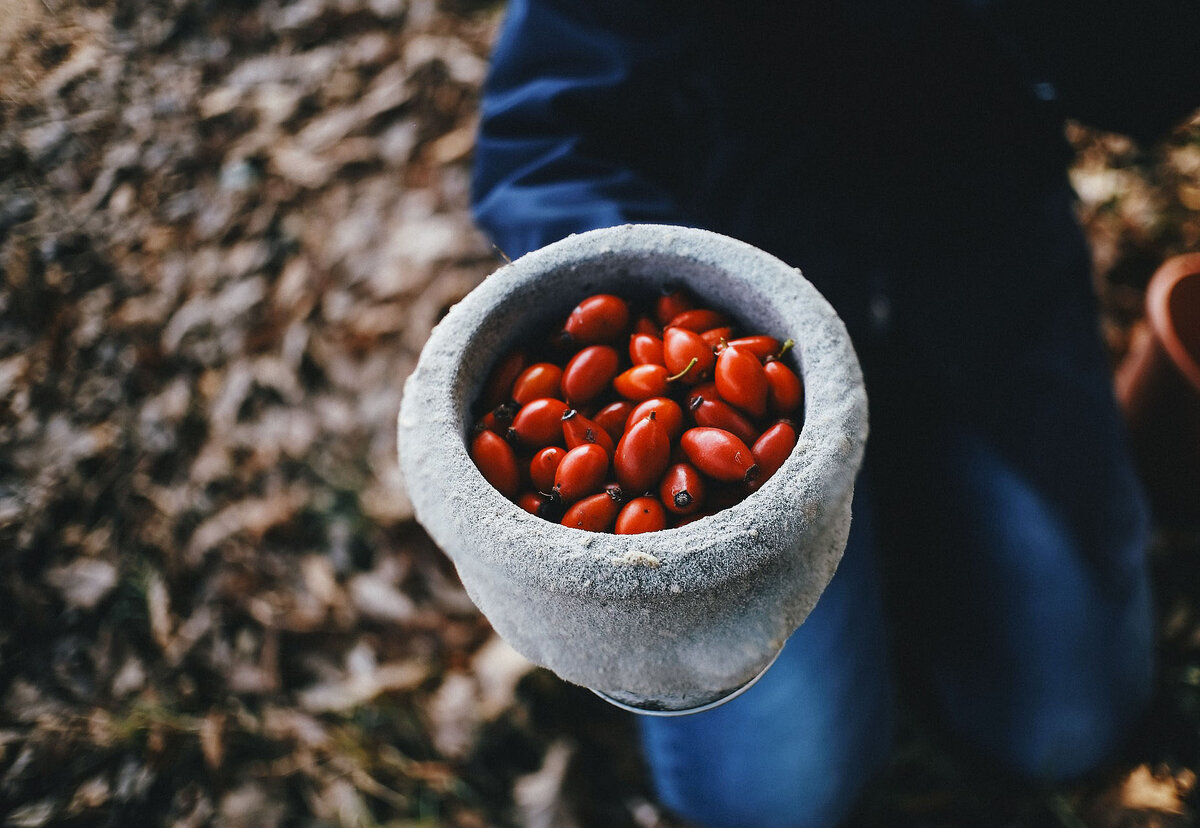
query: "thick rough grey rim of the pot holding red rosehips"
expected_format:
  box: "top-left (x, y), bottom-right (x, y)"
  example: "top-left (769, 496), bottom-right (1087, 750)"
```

top-left (397, 224), bottom-right (866, 602)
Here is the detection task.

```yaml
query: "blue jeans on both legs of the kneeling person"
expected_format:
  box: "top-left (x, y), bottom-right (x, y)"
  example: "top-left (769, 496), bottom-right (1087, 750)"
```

top-left (638, 188), bottom-right (1152, 826)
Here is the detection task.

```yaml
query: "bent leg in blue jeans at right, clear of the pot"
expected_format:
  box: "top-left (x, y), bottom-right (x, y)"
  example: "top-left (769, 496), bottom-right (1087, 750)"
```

top-left (874, 235), bottom-right (1153, 779)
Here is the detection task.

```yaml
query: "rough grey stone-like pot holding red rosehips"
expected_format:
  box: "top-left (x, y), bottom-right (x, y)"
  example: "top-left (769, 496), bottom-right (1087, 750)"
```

top-left (398, 224), bottom-right (866, 713)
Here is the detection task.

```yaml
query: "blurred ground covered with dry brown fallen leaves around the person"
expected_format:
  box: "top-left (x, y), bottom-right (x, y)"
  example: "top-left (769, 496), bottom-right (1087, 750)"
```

top-left (0, 0), bottom-right (1200, 828)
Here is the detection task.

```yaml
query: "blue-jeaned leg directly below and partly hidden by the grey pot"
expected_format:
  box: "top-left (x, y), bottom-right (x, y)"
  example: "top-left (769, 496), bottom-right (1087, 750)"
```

top-left (638, 491), bottom-right (892, 828)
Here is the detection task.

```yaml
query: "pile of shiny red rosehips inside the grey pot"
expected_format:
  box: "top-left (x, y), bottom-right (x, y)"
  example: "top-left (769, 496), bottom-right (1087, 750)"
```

top-left (470, 290), bottom-right (804, 534)
